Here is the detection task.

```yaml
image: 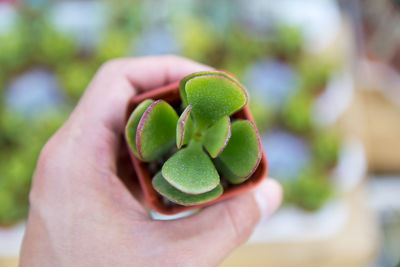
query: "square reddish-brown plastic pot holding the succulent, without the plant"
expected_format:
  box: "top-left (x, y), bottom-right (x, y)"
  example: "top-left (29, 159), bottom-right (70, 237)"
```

top-left (125, 82), bottom-right (268, 215)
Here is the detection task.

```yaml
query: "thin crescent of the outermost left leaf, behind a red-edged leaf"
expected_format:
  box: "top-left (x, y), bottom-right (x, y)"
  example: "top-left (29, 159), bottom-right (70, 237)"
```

top-left (125, 99), bottom-right (154, 158)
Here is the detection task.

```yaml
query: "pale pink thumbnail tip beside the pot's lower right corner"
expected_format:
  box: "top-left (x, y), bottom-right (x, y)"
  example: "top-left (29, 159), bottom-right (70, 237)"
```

top-left (254, 178), bottom-right (282, 217)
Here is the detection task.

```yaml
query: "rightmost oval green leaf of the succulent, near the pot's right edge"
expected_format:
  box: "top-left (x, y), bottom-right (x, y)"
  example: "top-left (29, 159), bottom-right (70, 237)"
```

top-left (219, 120), bottom-right (261, 178)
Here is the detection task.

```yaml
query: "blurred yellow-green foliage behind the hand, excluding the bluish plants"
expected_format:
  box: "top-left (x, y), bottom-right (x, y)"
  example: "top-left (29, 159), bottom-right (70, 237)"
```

top-left (0, 0), bottom-right (339, 225)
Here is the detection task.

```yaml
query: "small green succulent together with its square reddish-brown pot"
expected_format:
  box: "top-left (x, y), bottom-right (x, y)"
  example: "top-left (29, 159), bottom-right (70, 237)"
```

top-left (125, 71), bottom-right (267, 215)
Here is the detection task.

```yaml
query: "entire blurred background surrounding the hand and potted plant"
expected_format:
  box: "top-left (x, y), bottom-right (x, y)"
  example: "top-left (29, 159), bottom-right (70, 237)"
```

top-left (0, 0), bottom-right (400, 266)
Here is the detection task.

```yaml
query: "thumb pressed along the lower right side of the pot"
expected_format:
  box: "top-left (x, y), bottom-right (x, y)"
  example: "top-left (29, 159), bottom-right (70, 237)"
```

top-left (161, 178), bottom-right (282, 266)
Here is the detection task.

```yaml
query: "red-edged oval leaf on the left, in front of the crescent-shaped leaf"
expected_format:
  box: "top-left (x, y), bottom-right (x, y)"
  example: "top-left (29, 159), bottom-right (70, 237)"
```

top-left (136, 100), bottom-right (178, 162)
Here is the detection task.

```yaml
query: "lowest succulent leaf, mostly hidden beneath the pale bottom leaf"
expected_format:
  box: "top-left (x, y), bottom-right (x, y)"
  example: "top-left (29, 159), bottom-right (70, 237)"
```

top-left (153, 172), bottom-right (223, 206)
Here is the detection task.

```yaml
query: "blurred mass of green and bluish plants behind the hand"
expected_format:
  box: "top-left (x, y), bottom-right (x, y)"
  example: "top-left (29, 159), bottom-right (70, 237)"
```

top-left (0, 1), bottom-right (340, 225)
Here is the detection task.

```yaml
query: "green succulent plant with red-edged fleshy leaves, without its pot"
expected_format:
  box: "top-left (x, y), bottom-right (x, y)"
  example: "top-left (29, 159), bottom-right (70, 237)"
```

top-left (126, 71), bottom-right (261, 206)
